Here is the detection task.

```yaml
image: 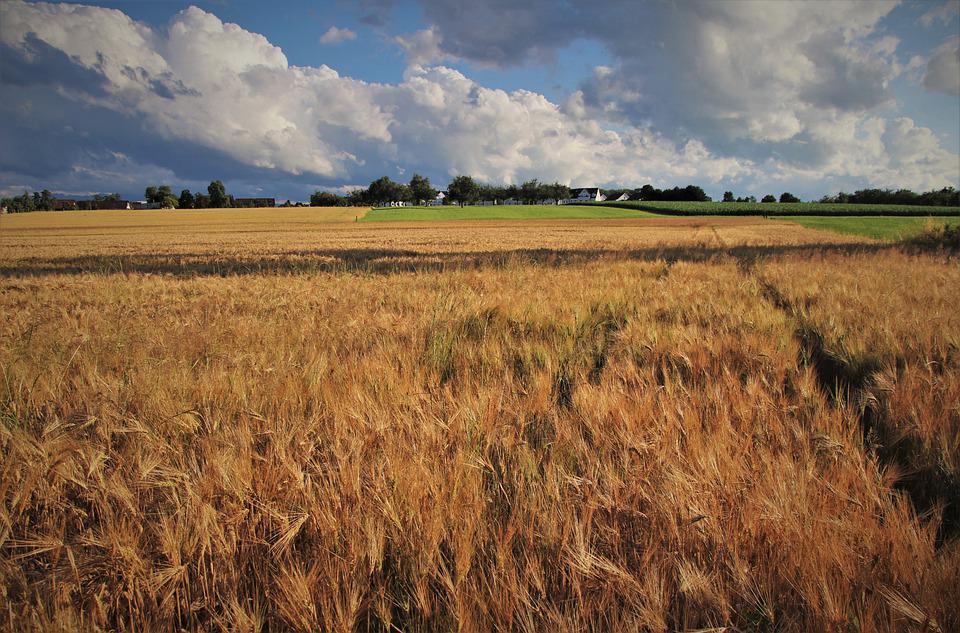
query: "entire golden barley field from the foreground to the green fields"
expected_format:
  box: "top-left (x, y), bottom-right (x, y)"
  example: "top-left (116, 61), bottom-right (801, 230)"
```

top-left (0, 209), bottom-right (960, 631)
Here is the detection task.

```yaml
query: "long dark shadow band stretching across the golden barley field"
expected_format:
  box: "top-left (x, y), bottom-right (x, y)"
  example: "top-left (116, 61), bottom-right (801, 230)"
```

top-left (0, 243), bottom-right (916, 278)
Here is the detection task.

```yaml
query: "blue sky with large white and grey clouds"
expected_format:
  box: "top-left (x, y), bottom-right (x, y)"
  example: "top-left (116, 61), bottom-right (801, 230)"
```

top-left (0, 0), bottom-right (960, 200)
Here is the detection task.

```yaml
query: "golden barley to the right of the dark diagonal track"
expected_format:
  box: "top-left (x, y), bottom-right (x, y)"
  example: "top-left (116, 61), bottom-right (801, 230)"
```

top-left (764, 253), bottom-right (960, 531)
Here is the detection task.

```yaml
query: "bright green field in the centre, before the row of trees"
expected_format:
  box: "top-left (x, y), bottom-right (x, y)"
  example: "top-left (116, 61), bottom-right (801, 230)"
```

top-left (360, 204), bottom-right (656, 222)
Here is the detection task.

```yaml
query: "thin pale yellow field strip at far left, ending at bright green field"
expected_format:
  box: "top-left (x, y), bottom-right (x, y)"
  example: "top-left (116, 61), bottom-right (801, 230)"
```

top-left (0, 207), bottom-right (367, 231)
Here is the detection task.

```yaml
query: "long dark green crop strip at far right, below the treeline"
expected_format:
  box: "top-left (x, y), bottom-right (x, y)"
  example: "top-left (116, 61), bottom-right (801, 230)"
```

top-left (597, 200), bottom-right (960, 216)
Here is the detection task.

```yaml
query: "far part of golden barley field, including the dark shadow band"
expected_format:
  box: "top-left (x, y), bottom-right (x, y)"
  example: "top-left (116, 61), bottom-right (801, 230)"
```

top-left (0, 209), bottom-right (866, 276)
